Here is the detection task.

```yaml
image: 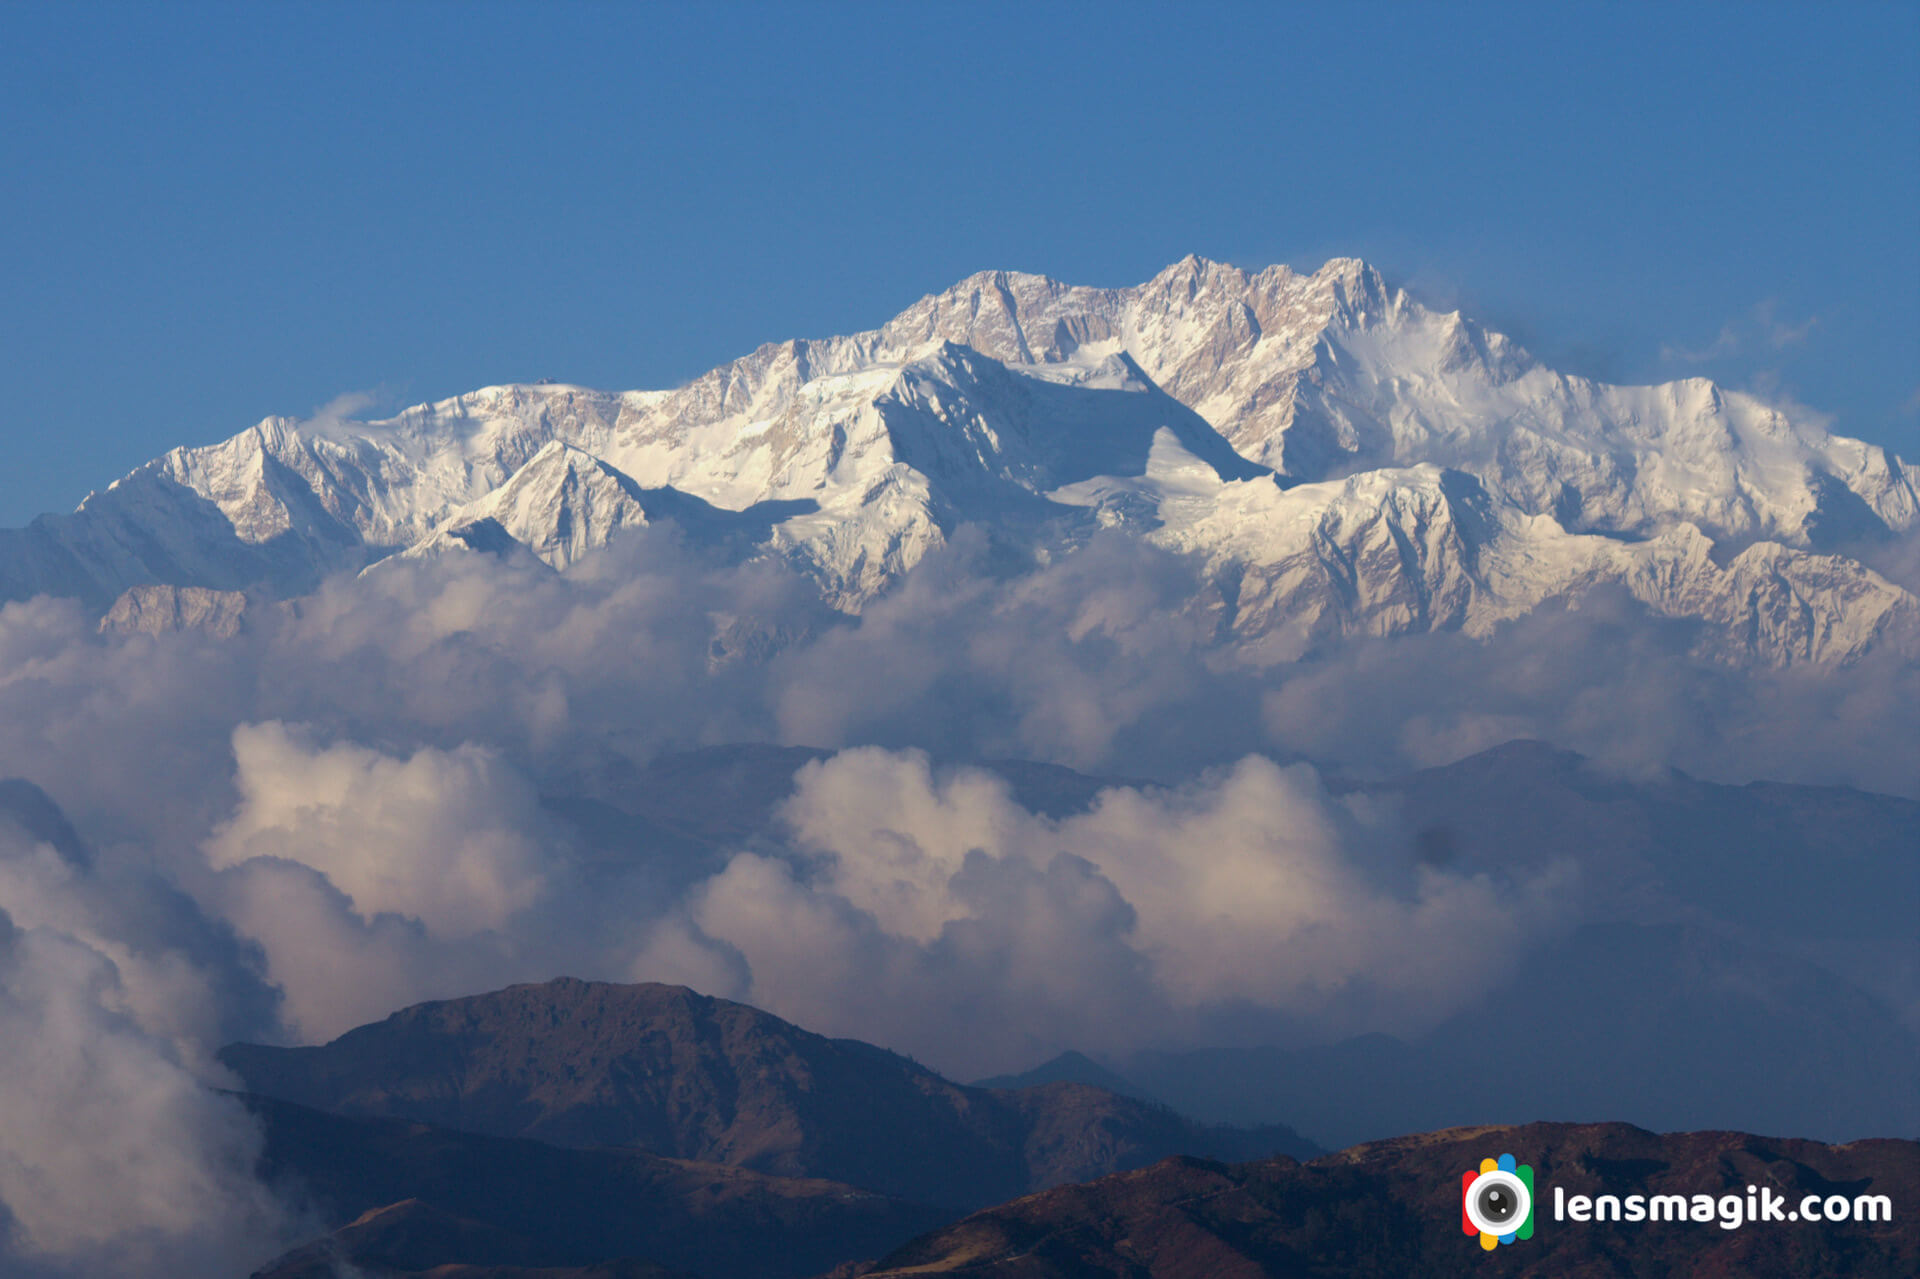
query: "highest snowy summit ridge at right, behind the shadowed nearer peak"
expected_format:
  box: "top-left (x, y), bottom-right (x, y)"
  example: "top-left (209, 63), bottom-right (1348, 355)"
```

top-left (864, 257), bottom-right (1920, 549)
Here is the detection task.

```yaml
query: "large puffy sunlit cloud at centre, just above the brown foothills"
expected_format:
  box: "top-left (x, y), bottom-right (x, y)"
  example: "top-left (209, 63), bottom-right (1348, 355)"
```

top-left (634, 747), bottom-right (1576, 1075)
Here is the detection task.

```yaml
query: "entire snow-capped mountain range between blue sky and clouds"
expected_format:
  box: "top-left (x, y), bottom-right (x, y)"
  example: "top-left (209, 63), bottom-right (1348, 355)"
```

top-left (0, 257), bottom-right (1920, 664)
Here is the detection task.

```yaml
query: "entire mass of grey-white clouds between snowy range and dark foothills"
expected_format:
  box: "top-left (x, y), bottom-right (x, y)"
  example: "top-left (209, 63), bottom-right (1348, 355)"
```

top-left (0, 530), bottom-right (1920, 1275)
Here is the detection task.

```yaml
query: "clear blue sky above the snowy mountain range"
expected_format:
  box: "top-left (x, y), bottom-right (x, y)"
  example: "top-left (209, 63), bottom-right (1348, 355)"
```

top-left (0, 2), bottom-right (1920, 524)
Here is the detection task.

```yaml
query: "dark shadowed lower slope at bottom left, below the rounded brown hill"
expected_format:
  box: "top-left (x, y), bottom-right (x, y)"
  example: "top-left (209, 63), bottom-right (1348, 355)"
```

top-left (246, 1095), bottom-right (952, 1279)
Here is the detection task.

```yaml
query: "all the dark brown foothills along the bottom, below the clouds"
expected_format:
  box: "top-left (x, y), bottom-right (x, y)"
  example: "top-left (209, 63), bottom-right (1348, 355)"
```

top-left (221, 979), bottom-right (1920, 1279)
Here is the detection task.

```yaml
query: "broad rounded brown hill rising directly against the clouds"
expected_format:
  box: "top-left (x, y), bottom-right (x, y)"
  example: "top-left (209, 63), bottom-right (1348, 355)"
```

top-left (221, 977), bottom-right (1317, 1210)
